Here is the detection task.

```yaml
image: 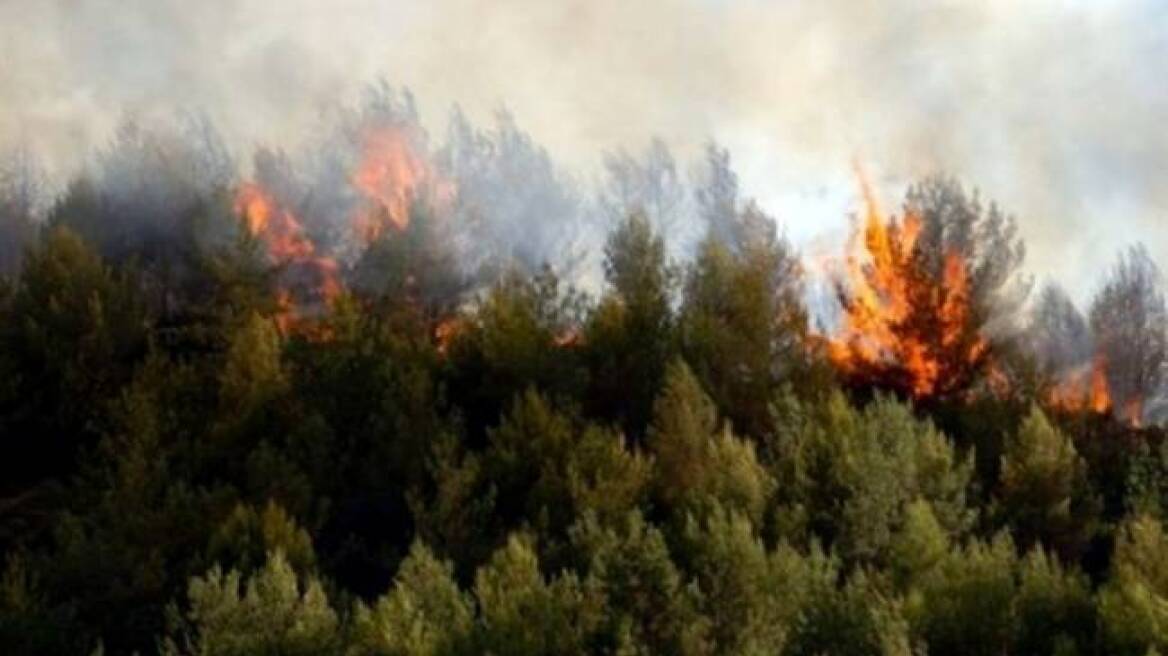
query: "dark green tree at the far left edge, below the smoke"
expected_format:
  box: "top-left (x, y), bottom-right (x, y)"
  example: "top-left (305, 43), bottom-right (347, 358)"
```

top-left (0, 229), bottom-right (147, 490)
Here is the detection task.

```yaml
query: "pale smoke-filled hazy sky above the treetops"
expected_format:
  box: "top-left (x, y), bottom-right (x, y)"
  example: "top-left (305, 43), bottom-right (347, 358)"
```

top-left (0, 0), bottom-right (1168, 298)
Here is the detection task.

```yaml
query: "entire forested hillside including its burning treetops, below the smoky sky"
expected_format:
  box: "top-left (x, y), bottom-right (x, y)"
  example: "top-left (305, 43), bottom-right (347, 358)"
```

top-left (0, 88), bottom-right (1168, 656)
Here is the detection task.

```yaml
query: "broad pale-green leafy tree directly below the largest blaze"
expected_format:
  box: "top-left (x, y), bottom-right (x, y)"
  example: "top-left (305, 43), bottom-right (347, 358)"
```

top-left (773, 387), bottom-right (973, 564)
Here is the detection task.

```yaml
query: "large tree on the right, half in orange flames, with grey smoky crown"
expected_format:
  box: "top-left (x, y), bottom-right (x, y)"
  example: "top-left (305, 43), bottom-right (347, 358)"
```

top-left (828, 176), bottom-right (1029, 398)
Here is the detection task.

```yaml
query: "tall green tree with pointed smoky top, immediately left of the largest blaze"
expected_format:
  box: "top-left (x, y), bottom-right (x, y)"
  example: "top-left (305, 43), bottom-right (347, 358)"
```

top-left (677, 146), bottom-right (812, 437)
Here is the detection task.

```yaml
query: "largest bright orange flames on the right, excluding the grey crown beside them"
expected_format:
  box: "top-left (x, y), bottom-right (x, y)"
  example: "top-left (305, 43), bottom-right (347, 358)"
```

top-left (828, 174), bottom-right (988, 398)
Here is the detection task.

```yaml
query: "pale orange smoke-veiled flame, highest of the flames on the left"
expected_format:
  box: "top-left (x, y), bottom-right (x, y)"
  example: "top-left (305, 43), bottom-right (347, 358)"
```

top-left (353, 127), bottom-right (453, 243)
